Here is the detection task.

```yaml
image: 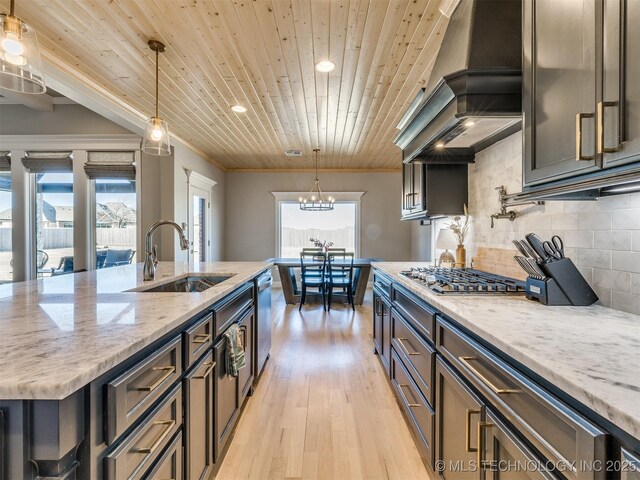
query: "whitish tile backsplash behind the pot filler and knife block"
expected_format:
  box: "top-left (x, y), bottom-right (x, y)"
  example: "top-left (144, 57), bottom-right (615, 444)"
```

top-left (468, 133), bottom-right (640, 314)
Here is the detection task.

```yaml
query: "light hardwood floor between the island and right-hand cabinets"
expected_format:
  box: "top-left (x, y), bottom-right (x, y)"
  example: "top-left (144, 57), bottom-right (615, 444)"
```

top-left (216, 290), bottom-right (429, 480)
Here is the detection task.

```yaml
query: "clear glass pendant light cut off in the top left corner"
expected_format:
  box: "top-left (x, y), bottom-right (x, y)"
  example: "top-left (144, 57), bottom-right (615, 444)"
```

top-left (0, 0), bottom-right (47, 93)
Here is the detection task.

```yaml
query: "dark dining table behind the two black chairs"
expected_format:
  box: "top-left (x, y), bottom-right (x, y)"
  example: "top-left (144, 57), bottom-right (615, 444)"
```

top-left (267, 257), bottom-right (382, 305)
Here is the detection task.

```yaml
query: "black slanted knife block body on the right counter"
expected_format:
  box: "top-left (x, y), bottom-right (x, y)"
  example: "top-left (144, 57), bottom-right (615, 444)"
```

top-left (526, 258), bottom-right (598, 306)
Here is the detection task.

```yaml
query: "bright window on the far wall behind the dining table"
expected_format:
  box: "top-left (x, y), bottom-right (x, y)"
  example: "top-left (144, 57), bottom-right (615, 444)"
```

top-left (278, 201), bottom-right (359, 258)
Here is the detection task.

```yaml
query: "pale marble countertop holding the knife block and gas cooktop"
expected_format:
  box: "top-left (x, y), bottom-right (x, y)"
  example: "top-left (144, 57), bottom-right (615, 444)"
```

top-left (373, 262), bottom-right (640, 439)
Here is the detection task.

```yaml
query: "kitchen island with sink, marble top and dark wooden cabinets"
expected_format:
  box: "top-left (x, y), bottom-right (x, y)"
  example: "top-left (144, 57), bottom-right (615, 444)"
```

top-left (0, 262), bottom-right (271, 479)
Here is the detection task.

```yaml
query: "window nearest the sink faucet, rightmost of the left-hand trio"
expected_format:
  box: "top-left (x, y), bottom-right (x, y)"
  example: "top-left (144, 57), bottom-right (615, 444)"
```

top-left (94, 178), bottom-right (137, 268)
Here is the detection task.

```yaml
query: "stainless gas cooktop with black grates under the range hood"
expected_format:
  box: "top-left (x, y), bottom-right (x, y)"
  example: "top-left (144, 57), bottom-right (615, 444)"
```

top-left (400, 267), bottom-right (525, 295)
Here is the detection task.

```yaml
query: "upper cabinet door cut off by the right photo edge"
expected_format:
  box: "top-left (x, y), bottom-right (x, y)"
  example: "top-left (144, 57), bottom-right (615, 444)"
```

top-left (598, 0), bottom-right (640, 168)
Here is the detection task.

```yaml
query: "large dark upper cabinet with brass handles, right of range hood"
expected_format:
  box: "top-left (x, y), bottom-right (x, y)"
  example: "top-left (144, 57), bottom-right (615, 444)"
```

top-left (523, 0), bottom-right (640, 190)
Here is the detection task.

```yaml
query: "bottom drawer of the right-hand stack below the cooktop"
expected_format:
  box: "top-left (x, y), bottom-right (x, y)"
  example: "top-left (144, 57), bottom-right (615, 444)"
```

top-left (391, 348), bottom-right (434, 467)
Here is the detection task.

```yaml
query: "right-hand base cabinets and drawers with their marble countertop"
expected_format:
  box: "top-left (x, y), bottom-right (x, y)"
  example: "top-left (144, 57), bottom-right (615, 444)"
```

top-left (372, 262), bottom-right (640, 479)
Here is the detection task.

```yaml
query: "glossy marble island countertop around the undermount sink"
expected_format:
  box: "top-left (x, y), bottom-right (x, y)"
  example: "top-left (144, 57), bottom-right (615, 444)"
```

top-left (0, 262), bottom-right (272, 400)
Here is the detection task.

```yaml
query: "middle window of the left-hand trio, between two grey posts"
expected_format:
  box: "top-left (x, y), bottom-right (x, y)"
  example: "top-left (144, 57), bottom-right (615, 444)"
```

top-left (33, 172), bottom-right (73, 277)
